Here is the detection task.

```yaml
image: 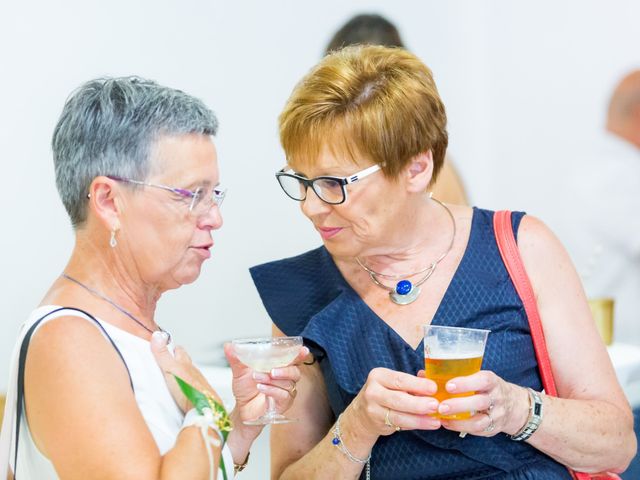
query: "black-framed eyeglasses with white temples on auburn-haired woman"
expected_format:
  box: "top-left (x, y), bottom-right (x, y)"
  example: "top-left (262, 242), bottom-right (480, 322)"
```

top-left (276, 165), bottom-right (380, 205)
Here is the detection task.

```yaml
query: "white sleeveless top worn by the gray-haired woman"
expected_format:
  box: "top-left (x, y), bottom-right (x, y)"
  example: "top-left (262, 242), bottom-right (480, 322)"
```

top-left (0, 305), bottom-right (233, 480)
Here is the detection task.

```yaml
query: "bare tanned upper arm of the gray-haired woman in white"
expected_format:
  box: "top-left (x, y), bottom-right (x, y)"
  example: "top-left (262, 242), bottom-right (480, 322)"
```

top-left (25, 317), bottom-right (161, 480)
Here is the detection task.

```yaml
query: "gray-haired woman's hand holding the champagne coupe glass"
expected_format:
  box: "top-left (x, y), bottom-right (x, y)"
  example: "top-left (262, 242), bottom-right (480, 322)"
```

top-left (224, 343), bottom-right (309, 426)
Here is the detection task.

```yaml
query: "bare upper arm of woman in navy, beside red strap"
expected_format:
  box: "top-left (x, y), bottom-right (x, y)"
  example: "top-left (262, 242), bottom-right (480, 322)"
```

top-left (518, 215), bottom-right (632, 414)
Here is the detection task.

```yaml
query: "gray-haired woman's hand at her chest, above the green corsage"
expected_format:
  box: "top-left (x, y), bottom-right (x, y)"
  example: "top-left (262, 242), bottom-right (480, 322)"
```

top-left (151, 332), bottom-right (222, 413)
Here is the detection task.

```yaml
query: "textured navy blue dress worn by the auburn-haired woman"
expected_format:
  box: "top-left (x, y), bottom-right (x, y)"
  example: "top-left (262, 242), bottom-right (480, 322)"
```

top-left (251, 209), bottom-right (571, 480)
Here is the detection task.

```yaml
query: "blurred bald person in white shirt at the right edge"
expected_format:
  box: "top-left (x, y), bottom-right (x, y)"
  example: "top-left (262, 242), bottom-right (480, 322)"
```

top-left (562, 70), bottom-right (640, 480)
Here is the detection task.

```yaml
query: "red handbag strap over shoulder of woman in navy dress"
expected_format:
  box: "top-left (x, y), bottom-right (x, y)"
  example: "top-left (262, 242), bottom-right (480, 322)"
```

top-left (493, 210), bottom-right (618, 480)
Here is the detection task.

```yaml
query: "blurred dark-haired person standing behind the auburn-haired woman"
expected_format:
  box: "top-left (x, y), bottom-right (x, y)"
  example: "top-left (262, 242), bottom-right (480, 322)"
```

top-left (325, 14), bottom-right (469, 205)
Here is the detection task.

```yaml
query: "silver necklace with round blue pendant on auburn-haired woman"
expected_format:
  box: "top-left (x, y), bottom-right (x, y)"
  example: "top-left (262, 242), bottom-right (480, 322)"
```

top-left (356, 197), bottom-right (456, 305)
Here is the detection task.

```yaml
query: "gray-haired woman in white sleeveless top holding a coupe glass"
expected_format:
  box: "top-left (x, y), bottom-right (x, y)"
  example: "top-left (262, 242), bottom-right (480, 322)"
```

top-left (0, 77), bottom-right (307, 480)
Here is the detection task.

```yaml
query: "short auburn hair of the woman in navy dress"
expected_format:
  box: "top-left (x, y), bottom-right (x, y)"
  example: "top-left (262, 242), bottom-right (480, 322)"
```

top-left (279, 45), bottom-right (448, 178)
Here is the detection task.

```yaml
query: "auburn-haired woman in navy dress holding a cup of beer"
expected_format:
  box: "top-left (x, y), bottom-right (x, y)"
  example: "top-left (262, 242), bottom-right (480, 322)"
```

top-left (251, 46), bottom-right (636, 480)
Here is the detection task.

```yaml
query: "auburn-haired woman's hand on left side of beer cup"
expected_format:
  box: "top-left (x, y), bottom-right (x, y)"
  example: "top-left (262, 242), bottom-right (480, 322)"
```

top-left (350, 368), bottom-right (441, 435)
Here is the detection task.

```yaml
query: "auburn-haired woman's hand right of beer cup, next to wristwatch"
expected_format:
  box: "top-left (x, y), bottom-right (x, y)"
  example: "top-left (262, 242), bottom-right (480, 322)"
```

top-left (438, 370), bottom-right (529, 437)
